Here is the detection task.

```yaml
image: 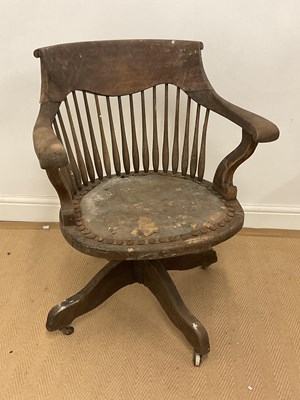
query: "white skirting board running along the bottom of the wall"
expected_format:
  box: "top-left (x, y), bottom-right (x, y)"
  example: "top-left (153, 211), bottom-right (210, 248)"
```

top-left (0, 196), bottom-right (300, 230)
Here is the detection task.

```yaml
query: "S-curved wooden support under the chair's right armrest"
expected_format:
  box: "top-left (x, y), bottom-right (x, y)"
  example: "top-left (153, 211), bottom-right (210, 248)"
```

top-left (213, 130), bottom-right (257, 200)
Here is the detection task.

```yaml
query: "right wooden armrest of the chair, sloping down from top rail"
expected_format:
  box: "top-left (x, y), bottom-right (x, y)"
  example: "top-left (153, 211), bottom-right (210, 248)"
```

top-left (187, 89), bottom-right (279, 143)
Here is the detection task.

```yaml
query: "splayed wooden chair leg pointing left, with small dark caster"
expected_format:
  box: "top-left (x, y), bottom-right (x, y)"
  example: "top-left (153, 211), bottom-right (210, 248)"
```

top-left (46, 261), bottom-right (135, 335)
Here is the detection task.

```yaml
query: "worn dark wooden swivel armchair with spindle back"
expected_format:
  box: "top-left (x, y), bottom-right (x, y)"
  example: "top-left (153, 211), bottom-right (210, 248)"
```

top-left (33, 40), bottom-right (279, 365)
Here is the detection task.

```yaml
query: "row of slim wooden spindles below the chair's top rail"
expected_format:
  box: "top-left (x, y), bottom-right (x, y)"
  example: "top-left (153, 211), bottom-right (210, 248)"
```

top-left (53, 84), bottom-right (209, 192)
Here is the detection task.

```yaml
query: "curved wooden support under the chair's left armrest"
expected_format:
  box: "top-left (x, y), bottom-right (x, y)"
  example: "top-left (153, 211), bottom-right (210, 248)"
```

top-left (46, 168), bottom-right (75, 226)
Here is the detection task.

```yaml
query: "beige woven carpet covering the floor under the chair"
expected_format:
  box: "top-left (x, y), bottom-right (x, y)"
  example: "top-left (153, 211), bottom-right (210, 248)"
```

top-left (0, 223), bottom-right (300, 400)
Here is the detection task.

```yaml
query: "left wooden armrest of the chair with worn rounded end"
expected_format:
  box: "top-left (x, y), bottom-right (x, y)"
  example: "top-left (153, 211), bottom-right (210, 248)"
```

top-left (33, 103), bottom-right (68, 169)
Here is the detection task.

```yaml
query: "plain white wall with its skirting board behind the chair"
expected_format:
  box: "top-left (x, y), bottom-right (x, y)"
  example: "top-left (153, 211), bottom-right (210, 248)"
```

top-left (0, 0), bottom-right (300, 229)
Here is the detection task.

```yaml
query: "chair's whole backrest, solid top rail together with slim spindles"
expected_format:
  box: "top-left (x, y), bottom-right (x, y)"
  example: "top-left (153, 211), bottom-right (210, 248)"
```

top-left (35, 40), bottom-right (211, 193)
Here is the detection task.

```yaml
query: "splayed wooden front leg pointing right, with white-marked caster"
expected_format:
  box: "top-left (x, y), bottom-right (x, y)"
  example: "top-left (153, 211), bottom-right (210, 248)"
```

top-left (139, 260), bottom-right (210, 365)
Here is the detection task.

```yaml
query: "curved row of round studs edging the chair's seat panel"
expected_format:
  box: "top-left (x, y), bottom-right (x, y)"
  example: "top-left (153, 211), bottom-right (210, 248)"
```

top-left (73, 177), bottom-right (236, 246)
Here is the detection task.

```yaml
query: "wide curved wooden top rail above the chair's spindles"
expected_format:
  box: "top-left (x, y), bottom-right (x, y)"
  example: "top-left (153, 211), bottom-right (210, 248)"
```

top-left (34, 40), bottom-right (211, 103)
